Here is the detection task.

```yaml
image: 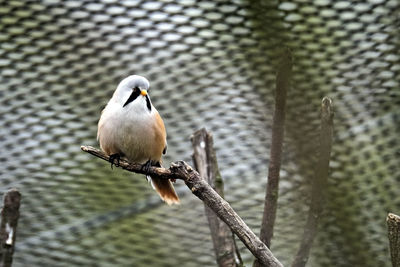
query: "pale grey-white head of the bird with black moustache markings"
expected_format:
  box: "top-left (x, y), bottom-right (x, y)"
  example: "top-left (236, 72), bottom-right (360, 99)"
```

top-left (113, 75), bottom-right (151, 111)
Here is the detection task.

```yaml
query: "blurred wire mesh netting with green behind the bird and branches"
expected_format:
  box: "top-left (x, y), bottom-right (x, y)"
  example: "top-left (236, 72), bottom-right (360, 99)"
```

top-left (0, 0), bottom-right (400, 267)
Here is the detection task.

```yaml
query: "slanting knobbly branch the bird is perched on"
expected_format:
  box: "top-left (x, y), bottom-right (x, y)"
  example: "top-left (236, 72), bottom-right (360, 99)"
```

top-left (81, 146), bottom-right (282, 267)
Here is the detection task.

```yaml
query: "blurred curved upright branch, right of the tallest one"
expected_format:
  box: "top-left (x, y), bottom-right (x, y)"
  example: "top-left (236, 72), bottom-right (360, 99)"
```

top-left (292, 97), bottom-right (333, 267)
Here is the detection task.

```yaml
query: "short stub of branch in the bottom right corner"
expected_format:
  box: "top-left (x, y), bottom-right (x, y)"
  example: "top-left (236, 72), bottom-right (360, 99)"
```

top-left (386, 213), bottom-right (400, 267)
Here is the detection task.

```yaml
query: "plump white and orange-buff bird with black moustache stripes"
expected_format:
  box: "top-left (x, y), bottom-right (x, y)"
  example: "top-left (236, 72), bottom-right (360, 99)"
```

top-left (97, 75), bottom-right (180, 205)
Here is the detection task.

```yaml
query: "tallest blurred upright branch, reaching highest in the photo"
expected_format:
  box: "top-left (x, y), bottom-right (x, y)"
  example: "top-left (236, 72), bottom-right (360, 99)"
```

top-left (260, 50), bottom-right (292, 253)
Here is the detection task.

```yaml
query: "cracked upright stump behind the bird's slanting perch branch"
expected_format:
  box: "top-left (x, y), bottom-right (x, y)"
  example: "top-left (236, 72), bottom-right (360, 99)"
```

top-left (191, 128), bottom-right (243, 267)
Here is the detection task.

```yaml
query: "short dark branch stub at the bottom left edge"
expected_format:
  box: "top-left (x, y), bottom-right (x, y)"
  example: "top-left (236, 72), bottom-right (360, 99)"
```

top-left (0, 189), bottom-right (21, 267)
